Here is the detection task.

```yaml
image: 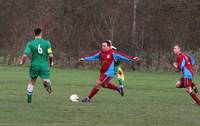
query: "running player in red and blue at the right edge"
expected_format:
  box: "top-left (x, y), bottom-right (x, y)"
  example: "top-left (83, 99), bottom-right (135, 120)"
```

top-left (173, 45), bottom-right (200, 105)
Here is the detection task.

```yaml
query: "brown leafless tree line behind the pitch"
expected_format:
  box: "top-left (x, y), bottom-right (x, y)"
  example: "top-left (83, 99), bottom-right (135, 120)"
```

top-left (0, 0), bottom-right (200, 70)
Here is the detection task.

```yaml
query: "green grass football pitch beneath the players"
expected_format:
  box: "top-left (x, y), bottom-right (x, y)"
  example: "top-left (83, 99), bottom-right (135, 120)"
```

top-left (0, 67), bottom-right (200, 126)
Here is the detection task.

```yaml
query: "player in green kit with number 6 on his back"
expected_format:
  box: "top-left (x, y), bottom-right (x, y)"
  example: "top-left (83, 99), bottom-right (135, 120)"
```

top-left (20, 28), bottom-right (53, 103)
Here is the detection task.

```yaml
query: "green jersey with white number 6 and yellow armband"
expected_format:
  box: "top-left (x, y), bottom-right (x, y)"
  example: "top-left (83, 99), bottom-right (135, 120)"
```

top-left (24, 38), bottom-right (52, 67)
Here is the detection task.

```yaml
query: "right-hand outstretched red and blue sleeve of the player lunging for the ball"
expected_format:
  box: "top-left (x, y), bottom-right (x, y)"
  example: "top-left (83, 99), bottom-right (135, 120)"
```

top-left (112, 51), bottom-right (133, 61)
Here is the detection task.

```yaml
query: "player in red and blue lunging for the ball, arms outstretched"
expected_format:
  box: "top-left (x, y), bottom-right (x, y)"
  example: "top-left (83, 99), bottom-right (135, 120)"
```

top-left (79, 41), bottom-right (139, 102)
